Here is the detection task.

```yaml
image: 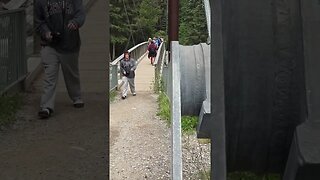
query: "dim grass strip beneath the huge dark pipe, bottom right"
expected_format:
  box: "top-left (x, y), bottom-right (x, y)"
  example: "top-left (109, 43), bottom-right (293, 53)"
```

top-left (227, 172), bottom-right (281, 180)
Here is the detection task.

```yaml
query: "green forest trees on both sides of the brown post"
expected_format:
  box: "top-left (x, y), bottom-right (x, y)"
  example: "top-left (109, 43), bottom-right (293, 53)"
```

top-left (110, 0), bottom-right (208, 57)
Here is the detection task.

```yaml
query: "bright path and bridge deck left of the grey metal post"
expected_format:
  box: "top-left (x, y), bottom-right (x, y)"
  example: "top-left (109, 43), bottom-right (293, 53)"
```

top-left (110, 58), bottom-right (170, 180)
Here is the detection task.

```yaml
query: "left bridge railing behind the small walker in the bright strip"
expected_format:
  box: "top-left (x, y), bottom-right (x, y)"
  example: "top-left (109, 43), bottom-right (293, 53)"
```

top-left (109, 42), bottom-right (148, 91)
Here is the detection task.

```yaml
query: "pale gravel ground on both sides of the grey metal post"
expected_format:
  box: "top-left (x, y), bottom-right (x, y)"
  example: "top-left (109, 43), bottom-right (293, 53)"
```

top-left (110, 92), bottom-right (210, 180)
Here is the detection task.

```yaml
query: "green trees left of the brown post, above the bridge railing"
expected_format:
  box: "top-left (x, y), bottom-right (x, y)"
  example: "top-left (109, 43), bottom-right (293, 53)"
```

top-left (109, 0), bottom-right (166, 57)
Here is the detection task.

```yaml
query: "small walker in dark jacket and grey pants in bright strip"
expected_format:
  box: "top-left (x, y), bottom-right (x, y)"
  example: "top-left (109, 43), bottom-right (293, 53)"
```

top-left (120, 51), bottom-right (137, 99)
